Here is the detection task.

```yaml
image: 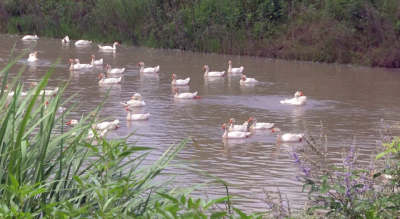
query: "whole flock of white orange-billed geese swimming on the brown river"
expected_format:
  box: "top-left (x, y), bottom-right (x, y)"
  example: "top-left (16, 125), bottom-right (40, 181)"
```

top-left (18, 35), bottom-right (307, 142)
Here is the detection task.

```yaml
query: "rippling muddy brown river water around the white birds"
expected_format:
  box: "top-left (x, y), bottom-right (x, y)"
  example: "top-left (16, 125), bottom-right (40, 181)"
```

top-left (0, 35), bottom-right (400, 211)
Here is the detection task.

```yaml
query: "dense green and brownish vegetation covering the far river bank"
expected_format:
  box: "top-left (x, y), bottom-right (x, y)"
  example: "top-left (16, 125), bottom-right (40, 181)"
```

top-left (0, 0), bottom-right (400, 67)
